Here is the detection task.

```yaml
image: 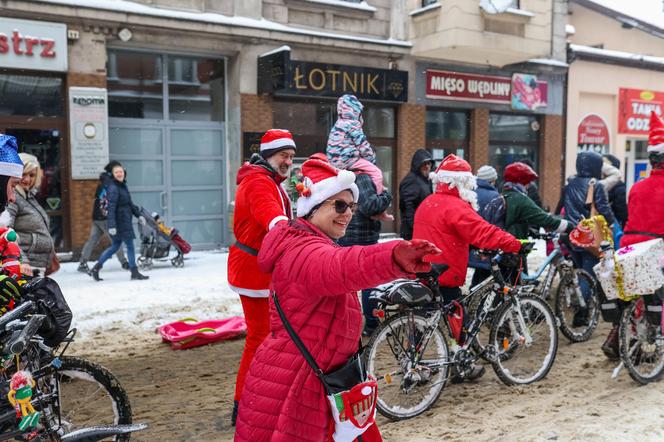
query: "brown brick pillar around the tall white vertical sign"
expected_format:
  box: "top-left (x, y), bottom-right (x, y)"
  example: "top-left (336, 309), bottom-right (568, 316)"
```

top-left (67, 72), bottom-right (109, 259)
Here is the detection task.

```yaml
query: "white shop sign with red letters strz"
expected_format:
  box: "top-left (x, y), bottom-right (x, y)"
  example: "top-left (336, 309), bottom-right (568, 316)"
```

top-left (0, 17), bottom-right (67, 72)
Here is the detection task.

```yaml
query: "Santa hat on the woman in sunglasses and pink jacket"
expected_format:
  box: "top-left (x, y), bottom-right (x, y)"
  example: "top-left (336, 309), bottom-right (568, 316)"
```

top-left (296, 160), bottom-right (360, 218)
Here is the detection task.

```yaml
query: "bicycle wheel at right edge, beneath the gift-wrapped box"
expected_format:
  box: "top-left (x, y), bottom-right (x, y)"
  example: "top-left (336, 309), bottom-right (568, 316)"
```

top-left (619, 298), bottom-right (664, 384)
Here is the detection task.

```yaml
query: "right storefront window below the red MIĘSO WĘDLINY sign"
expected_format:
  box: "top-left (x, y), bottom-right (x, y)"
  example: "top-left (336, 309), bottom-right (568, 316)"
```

top-left (489, 112), bottom-right (540, 176)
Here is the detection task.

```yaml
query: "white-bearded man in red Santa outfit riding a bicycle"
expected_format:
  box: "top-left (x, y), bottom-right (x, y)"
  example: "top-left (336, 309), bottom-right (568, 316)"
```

top-left (413, 155), bottom-right (521, 381)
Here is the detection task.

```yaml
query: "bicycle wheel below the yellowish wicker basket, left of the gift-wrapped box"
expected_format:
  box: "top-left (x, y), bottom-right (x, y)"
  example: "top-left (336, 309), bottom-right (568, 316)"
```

top-left (555, 269), bottom-right (600, 342)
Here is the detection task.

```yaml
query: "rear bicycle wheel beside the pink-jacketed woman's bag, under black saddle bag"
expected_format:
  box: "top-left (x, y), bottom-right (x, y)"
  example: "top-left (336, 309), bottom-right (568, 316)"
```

top-left (365, 312), bottom-right (448, 420)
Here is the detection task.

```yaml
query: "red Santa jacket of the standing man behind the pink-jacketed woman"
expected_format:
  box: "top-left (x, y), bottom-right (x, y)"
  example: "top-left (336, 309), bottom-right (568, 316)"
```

top-left (228, 163), bottom-right (292, 298)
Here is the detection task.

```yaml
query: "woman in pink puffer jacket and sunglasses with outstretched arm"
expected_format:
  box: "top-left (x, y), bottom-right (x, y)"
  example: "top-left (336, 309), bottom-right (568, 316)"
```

top-left (235, 160), bottom-right (439, 442)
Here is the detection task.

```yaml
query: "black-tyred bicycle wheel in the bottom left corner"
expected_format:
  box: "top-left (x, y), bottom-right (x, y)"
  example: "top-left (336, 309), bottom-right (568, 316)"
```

top-left (51, 356), bottom-right (132, 441)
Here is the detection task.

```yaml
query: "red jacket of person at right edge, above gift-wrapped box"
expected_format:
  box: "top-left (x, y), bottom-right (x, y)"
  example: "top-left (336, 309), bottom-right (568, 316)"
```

top-left (620, 169), bottom-right (664, 247)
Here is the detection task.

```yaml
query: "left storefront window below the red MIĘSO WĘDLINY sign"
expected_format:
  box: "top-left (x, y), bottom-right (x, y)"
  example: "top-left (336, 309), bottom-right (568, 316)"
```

top-left (426, 109), bottom-right (470, 162)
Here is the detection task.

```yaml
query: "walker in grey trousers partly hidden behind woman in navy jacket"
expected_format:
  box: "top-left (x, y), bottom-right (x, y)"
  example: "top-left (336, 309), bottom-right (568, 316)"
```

top-left (77, 163), bottom-right (129, 273)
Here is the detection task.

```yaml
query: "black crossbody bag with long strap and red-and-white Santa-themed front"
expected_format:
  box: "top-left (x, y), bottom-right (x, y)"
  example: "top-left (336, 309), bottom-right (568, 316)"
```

top-left (272, 292), bottom-right (378, 442)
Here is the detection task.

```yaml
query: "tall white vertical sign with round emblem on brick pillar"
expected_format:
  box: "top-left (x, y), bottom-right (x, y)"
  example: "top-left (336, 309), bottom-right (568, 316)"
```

top-left (69, 87), bottom-right (108, 180)
